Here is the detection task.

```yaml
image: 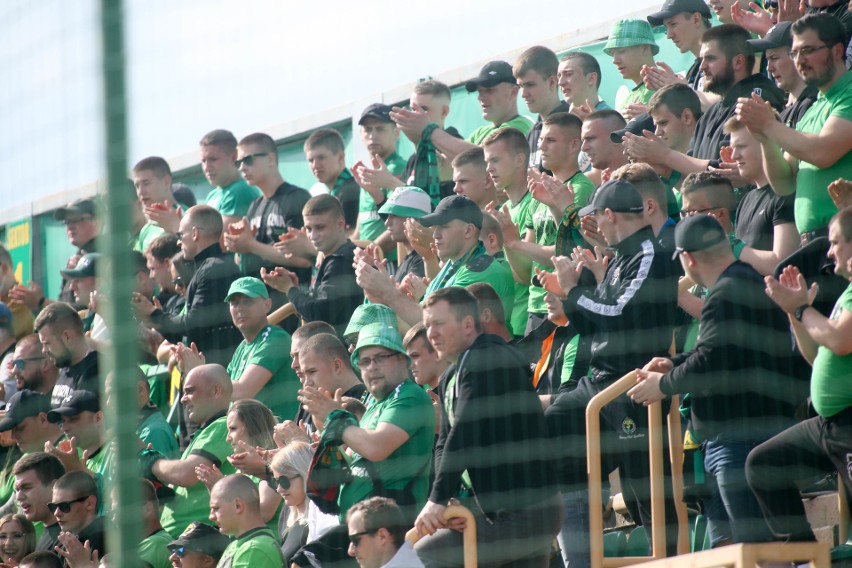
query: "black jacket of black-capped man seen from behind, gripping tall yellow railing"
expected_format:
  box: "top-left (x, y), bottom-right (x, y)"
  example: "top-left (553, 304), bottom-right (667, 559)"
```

top-left (660, 261), bottom-right (808, 439)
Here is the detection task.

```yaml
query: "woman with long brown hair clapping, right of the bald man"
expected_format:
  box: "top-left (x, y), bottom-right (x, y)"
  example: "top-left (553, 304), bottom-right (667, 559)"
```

top-left (195, 398), bottom-right (283, 531)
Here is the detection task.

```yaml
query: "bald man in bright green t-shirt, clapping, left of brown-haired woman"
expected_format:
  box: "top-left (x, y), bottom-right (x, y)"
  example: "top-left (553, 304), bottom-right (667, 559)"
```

top-left (139, 364), bottom-right (236, 534)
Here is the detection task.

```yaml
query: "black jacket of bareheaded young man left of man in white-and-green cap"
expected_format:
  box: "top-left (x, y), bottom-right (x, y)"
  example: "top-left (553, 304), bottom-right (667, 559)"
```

top-left (287, 240), bottom-right (364, 337)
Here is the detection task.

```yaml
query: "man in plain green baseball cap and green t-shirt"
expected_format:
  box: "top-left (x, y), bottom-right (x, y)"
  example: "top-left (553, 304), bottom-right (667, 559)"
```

top-left (225, 276), bottom-right (299, 420)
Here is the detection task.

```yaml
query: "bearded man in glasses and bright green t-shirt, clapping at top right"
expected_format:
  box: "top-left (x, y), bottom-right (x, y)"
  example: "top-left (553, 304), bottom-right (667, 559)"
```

top-left (736, 14), bottom-right (852, 237)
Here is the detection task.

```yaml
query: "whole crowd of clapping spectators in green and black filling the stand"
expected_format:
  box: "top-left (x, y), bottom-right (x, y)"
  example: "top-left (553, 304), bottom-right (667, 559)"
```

top-left (0, 0), bottom-right (852, 568)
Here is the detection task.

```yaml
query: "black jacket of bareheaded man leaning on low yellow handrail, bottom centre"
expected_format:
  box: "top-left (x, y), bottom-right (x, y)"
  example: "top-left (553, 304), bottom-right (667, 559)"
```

top-left (429, 335), bottom-right (557, 515)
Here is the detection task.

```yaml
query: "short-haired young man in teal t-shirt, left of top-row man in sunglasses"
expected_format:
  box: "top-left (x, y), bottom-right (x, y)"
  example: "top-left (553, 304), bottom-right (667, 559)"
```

top-left (198, 130), bottom-right (261, 227)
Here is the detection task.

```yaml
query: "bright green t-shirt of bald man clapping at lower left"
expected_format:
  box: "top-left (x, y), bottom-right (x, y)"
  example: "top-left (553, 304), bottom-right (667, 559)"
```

top-left (160, 416), bottom-right (236, 534)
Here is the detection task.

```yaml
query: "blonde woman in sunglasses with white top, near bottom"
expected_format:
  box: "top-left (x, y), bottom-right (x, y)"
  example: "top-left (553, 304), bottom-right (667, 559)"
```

top-left (269, 442), bottom-right (338, 566)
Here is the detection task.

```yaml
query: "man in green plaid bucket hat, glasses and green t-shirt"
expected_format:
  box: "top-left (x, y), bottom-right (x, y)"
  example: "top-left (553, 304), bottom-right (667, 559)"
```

top-left (300, 323), bottom-right (435, 520)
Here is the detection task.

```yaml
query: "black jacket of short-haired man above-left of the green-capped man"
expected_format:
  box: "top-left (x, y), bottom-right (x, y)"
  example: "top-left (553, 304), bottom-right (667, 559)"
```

top-left (151, 243), bottom-right (243, 367)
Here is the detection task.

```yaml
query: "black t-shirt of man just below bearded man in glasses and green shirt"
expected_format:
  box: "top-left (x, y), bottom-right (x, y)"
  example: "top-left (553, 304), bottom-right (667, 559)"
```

top-left (734, 185), bottom-right (795, 250)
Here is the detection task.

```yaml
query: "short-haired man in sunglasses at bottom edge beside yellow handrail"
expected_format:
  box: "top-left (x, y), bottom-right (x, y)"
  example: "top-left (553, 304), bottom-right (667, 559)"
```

top-left (346, 497), bottom-right (423, 568)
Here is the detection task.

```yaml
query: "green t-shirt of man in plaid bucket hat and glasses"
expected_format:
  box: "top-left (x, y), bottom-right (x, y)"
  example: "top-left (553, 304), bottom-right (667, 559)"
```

top-left (339, 379), bottom-right (435, 519)
